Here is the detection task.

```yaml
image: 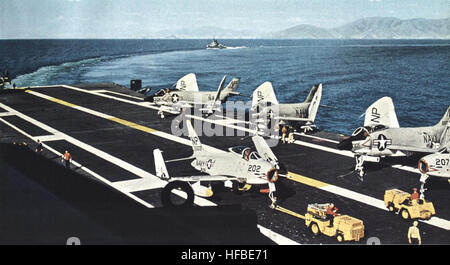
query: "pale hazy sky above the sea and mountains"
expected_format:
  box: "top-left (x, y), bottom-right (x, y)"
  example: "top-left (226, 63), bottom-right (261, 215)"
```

top-left (0, 0), bottom-right (450, 39)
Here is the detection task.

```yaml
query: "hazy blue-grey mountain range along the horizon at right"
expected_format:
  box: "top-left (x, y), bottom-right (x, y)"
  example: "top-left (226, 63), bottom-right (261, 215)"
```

top-left (154, 17), bottom-right (450, 39)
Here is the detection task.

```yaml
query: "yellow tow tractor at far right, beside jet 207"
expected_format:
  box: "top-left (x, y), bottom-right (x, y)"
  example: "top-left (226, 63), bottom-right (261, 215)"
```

top-left (384, 189), bottom-right (436, 220)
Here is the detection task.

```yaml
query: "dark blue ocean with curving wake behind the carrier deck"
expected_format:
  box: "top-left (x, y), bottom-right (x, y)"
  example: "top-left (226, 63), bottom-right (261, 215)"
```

top-left (0, 40), bottom-right (450, 134)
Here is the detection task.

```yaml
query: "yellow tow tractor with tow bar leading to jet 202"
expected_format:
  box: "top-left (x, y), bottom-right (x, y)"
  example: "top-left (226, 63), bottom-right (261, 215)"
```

top-left (275, 203), bottom-right (364, 242)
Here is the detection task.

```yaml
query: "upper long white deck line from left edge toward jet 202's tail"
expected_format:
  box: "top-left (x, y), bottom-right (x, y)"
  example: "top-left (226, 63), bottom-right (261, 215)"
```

top-left (0, 103), bottom-right (216, 206)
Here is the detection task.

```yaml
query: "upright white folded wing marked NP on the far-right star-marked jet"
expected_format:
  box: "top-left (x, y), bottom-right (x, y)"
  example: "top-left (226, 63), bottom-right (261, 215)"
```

top-left (364, 97), bottom-right (400, 128)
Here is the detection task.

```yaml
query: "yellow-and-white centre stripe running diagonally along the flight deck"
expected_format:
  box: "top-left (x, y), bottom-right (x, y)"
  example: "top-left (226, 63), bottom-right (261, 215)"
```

top-left (22, 87), bottom-right (450, 230)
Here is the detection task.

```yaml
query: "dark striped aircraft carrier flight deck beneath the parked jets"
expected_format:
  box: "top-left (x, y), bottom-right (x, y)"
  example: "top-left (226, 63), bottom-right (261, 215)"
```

top-left (0, 84), bottom-right (450, 244)
